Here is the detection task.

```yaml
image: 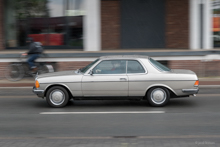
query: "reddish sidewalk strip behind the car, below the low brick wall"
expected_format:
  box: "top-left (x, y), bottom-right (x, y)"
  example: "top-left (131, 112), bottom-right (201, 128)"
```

top-left (0, 77), bottom-right (220, 88)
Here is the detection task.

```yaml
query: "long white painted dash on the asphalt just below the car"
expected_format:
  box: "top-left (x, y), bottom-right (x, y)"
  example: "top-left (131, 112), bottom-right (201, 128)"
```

top-left (40, 111), bottom-right (165, 114)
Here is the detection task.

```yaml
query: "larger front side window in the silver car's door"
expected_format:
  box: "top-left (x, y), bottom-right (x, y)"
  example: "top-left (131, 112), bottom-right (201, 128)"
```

top-left (93, 60), bottom-right (126, 74)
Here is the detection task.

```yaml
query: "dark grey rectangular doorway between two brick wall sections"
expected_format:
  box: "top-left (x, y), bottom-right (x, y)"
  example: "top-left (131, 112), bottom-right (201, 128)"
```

top-left (121, 0), bottom-right (165, 49)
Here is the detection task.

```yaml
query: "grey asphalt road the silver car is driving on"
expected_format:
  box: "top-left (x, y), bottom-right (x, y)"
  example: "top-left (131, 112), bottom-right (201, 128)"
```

top-left (0, 88), bottom-right (220, 147)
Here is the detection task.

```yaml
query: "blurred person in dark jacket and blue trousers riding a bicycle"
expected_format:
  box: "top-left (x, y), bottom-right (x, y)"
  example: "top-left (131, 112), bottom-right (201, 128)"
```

top-left (24, 37), bottom-right (43, 73)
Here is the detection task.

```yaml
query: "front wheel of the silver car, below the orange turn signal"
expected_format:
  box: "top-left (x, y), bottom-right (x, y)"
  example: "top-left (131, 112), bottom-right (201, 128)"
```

top-left (46, 86), bottom-right (69, 108)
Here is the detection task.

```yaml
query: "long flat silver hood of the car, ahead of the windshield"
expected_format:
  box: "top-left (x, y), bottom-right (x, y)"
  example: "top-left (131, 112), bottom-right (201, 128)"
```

top-left (37, 70), bottom-right (78, 78)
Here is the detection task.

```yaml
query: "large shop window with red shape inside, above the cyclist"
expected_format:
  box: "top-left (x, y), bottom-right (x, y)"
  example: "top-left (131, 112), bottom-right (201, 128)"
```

top-left (4, 0), bottom-right (84, 49)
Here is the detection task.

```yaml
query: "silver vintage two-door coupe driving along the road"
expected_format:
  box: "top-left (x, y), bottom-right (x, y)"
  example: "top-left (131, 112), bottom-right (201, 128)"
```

top-left (33, 55), bottom-right (199, 107)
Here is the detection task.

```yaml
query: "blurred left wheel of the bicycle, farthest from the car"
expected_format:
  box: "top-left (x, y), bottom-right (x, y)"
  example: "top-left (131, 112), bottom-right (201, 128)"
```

top-left (5, 64), bottom-right (24, 81)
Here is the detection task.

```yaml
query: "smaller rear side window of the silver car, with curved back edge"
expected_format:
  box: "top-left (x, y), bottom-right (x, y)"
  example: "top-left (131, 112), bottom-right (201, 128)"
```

top-left (127, 60), bottom-right (145, 73)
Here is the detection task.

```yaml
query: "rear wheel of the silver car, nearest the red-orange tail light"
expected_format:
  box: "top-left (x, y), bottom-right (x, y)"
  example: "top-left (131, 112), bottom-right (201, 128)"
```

top-left (147, 87), bottom-right (170, 107)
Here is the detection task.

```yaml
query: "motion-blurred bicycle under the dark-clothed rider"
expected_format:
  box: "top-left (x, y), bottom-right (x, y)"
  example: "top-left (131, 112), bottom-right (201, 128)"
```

top-left (5, 53), bottom-right (54, 81)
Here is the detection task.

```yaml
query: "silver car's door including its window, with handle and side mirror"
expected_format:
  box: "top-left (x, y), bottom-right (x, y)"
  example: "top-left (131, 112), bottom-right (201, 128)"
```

top-left (82, 60), bottom-right (128, 97)
